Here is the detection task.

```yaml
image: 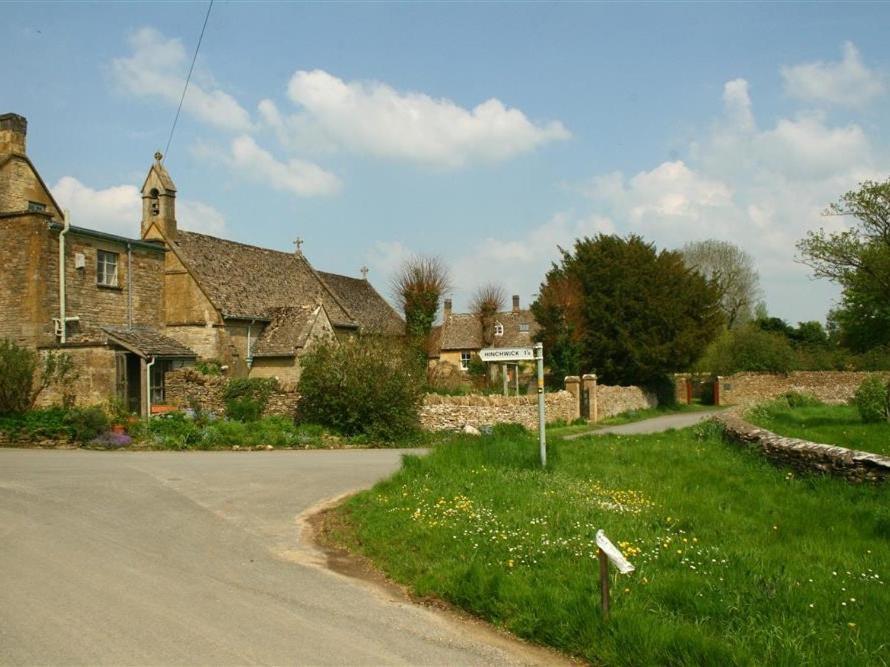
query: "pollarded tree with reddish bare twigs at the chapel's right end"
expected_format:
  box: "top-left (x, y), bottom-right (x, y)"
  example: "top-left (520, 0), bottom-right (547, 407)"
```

top-left (392, 255), bottom-right (451, 344)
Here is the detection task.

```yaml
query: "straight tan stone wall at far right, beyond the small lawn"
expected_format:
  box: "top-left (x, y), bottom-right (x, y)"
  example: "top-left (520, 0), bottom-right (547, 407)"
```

top-left (717, 371), bottom-right (890, 405)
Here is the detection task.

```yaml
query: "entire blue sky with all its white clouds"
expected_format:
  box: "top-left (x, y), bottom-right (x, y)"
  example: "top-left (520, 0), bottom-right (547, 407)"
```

top-left (0, 0), bottom-right (890, 323)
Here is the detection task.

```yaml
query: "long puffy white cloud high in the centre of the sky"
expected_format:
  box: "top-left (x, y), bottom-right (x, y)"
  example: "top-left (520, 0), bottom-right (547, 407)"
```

top-left (259, 70), bottom-right (571, 167)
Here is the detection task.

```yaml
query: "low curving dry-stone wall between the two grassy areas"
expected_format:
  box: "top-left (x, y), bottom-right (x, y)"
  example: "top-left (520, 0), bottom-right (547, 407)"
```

top-left (717, 414), bottom-right (890, 482)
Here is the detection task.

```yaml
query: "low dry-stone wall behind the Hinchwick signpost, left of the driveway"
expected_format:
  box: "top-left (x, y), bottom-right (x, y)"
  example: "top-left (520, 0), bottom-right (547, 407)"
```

top-left (420, 391), bottom-right (578, 431)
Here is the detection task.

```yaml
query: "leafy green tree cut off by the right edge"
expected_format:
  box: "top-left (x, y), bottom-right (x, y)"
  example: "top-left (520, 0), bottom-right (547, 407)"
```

top-left (797, 179), bottom-right (890, 352)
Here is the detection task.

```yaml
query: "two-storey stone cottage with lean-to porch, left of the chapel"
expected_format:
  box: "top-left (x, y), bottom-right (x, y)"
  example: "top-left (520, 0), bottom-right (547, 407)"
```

top-left (0, 114), bottom-right (195, 413)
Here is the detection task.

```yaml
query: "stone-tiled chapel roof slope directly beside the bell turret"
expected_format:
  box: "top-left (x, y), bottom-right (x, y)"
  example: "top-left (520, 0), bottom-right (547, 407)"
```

top-left (173, 230), bottom-right (358, 328)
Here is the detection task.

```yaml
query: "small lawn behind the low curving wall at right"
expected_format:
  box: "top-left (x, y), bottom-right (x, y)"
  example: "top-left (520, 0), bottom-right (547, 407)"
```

top-left (748, 401), bottom-right (890, 456)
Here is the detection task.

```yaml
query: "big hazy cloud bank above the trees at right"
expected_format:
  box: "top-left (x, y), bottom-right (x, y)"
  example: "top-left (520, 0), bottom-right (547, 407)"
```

top-left (582, 79), bottom-right (890, 319)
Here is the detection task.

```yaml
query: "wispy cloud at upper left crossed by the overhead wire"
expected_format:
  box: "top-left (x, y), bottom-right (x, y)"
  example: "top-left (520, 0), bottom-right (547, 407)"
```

top-left (111, 28), bottom-right (252, 132)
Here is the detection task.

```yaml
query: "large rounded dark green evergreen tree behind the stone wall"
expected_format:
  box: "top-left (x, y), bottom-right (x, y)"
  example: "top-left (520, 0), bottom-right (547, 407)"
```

top-left (532, 234), bottom-right (724, 386)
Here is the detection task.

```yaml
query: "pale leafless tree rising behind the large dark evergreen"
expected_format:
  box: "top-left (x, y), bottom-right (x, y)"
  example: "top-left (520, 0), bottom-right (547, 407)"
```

top-left (680, 239), bottom-right (761, 329)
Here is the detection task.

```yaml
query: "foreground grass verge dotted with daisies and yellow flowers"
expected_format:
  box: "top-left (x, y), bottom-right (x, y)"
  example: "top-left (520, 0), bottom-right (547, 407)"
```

top-left (333, 424), bottom-right (890, 665)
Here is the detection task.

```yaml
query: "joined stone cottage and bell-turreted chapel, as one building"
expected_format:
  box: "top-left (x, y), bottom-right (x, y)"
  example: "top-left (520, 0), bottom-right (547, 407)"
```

top-left (0, 114), bottom-right (404, 414)
